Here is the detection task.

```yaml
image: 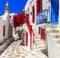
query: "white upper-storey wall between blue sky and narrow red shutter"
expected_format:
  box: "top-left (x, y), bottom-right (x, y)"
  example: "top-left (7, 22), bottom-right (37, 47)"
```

top-left (24, 0), bottom-right (35, 25)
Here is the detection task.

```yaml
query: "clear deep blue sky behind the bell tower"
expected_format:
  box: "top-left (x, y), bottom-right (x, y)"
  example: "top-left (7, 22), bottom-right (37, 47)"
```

top-left (0, 0), bottom-right (27, 15)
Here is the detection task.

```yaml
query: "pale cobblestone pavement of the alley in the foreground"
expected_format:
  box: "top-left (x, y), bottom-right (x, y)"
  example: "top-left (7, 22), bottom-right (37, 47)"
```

top-left (0, 40), bottom-right (47, 58)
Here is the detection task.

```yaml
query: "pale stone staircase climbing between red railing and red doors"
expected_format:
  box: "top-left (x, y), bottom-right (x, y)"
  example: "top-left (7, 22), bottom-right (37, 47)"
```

top-left (33, 26), bottom-right (45, 51)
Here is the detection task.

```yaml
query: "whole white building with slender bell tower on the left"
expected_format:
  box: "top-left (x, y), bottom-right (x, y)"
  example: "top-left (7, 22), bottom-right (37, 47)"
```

top-left (0, 3), bottom-right (10, 51)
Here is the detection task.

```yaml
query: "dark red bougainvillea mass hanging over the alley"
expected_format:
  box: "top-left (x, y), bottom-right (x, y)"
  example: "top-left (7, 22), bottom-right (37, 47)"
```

top-left (13, 12), bottom-right (25, 28)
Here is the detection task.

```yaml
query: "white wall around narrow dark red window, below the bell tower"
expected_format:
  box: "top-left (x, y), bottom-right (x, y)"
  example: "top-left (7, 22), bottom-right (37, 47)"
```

top-left (0, 14), bottom-right (9, 42)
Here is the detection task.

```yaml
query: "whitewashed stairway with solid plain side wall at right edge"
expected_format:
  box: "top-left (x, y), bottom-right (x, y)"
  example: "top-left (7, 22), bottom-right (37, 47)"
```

top-left (46, 26), bottom-right (60, 58)
